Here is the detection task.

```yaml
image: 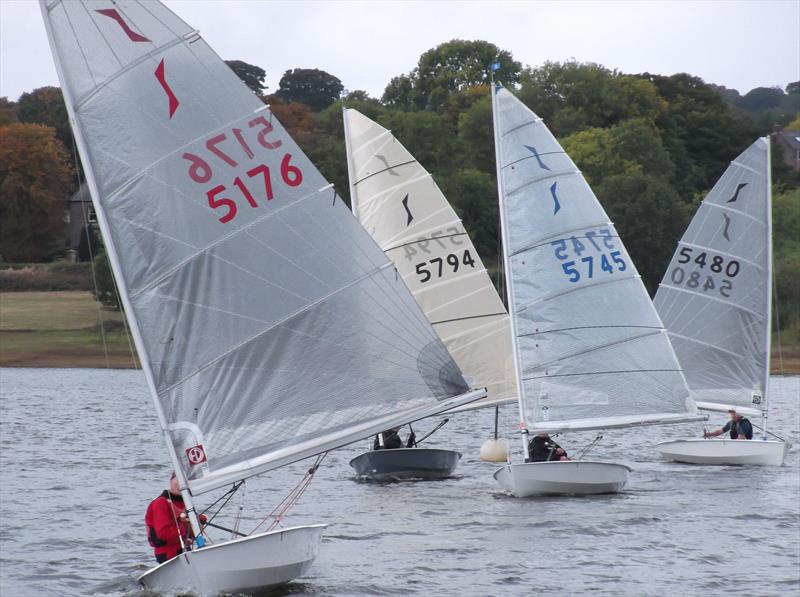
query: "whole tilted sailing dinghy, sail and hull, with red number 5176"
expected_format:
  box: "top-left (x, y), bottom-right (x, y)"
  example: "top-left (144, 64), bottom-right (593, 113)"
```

top-left (40, 0), bottom-right (485, 594)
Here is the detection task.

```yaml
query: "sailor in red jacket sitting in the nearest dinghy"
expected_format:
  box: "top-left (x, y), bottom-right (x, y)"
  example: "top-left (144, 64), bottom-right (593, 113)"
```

top-left (144, 473), bottom-right (192, 564)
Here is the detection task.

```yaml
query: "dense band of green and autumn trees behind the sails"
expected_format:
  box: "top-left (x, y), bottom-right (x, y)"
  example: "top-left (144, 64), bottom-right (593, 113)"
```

top-left (0, 40), bottom-right (800, 339)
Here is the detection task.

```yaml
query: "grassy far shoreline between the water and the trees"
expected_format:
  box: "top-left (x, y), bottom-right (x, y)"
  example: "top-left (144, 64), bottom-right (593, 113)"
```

top-left (0, 291), bottom-right (800, 375)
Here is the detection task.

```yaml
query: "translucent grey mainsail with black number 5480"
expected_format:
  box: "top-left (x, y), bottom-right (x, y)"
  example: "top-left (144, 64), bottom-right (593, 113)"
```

top-left (655, 138), bottom-right (772, 413)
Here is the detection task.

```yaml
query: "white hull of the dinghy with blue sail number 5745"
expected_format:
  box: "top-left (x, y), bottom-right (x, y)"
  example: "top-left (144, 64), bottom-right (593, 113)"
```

top-left (494, 460), bottom-right (631, 498)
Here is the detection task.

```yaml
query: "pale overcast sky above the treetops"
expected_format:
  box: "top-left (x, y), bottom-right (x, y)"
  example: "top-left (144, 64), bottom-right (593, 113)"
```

top-left (0, 0), bottom-right (800, 100)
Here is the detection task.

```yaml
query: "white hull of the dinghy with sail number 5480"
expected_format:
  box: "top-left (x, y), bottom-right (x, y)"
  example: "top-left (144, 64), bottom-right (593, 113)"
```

top-left (656, 439), bottom-right (790, 466)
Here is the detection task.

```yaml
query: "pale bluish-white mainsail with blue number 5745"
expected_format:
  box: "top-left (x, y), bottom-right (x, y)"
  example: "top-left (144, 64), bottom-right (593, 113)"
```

top-left (492, 85), bottom-right (698, 430)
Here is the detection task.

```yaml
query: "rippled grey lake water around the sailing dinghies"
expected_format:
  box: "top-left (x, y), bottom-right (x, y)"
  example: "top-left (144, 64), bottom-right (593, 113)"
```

top-left (0, 369), bottom-right (800, 597)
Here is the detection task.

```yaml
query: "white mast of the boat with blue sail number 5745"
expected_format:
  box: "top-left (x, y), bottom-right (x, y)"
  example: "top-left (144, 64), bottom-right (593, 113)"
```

top-left (490, 79), bottom-right (530, 462)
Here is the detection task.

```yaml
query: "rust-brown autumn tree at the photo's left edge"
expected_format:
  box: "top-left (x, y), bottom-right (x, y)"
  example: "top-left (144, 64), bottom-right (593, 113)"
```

top-left (0, 123), bottom-right (70, 261)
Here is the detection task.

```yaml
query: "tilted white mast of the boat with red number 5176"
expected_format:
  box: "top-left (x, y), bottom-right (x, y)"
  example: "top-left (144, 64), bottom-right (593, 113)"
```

top-left (39, 0), bottom-right (200, 537)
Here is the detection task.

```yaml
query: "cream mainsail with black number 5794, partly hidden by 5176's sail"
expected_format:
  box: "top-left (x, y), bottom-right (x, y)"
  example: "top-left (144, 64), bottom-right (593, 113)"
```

top-left (343, 109), bottom-right (517, 410)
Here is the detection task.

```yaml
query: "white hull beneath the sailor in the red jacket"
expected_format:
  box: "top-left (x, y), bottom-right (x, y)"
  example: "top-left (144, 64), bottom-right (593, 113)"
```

top-left (139, 524), bottom-right (326, 595)
